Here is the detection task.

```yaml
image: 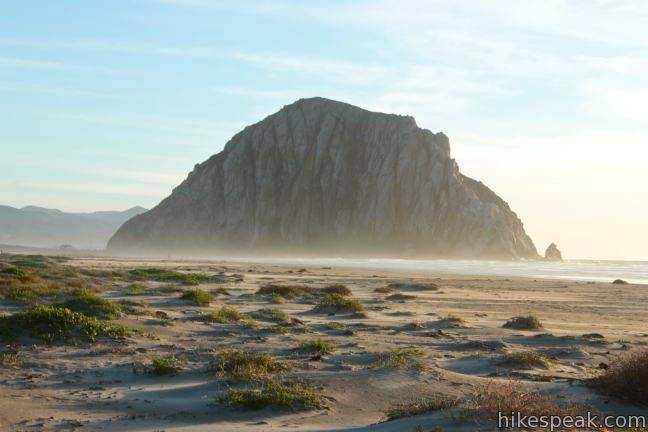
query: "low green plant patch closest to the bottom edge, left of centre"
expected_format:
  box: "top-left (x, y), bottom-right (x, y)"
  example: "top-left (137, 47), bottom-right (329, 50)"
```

top-left (222, 381), bottom-right (322, 409)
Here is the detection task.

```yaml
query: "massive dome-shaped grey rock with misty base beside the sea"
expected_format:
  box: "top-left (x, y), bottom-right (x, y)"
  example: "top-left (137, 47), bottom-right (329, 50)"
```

top-left (108, 98), bottom-right (538, 259)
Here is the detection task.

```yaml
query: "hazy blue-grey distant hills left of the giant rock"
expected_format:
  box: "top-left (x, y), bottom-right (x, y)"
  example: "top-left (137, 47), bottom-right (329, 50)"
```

top-left (0, 205), bottom-right (146, 249)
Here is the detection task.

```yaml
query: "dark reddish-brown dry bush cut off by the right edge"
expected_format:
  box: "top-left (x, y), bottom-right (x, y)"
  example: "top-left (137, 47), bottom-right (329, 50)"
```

top-left (593, 349), bottom-right (648, 404)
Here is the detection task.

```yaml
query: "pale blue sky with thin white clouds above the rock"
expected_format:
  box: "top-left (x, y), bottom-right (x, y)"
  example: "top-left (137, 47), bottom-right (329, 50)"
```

top-left (0, 0), bottom-right (648, 260)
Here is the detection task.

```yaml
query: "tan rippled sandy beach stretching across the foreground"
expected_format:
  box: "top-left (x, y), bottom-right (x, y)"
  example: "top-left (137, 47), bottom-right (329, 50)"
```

top-left (0, 255), bottom-right (648, 431)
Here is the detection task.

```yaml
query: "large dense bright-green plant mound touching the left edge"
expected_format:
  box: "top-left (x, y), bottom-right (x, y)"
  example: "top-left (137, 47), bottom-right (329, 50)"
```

top-left (0, 306), bottom-right (130, 343)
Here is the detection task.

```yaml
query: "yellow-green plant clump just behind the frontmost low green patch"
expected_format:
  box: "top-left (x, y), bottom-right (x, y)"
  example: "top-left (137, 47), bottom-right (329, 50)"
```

top-left (213, 351), bottom-right (288, 380)
